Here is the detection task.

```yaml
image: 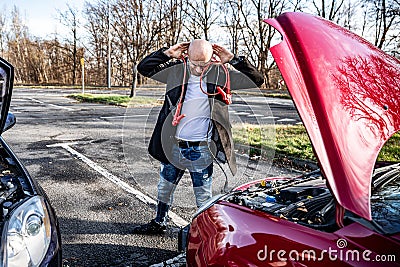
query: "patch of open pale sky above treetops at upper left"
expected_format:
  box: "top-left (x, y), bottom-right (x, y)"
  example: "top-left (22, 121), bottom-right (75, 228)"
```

top-left (0, 0), bottom-right (84, 38)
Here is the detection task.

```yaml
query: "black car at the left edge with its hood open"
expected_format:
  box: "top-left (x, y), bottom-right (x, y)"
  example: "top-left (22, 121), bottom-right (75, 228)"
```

top-left (0, 58), bottom-right (62, 267)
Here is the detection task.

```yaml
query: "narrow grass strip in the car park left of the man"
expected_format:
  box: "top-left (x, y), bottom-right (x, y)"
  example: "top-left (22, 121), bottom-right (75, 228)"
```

top-left (67, 94), bottom-right (161, 107)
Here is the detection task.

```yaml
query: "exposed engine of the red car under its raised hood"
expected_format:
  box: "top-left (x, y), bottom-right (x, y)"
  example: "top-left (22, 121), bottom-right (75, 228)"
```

top-left (225, 171), bottom-right (335, 228)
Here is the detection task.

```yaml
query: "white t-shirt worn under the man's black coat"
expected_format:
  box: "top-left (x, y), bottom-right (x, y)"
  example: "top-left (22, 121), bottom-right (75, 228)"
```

top-left (176, 75), bottom-right (212, 141)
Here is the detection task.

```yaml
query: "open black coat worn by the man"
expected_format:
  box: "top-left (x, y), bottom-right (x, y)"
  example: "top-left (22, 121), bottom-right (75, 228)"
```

top-left (137, 48), bottom-right (264, 175)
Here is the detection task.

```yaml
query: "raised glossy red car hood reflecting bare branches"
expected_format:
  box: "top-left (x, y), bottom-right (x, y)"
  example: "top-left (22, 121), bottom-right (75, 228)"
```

top-left (265, 13), bottom-right (400, 220)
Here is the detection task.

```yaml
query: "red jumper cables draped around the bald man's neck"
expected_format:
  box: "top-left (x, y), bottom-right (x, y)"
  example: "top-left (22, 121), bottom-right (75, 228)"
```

top-left (172, 57), bottom-right (232, 126)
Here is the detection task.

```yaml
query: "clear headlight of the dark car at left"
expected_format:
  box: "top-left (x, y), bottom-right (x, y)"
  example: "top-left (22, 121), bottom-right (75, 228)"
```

top-left (2, 196), bottom-right (51, 267)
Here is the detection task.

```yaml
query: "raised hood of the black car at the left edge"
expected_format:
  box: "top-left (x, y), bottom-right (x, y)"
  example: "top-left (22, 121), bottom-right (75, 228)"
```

top-left (0, 58), bottom-right (14, 134)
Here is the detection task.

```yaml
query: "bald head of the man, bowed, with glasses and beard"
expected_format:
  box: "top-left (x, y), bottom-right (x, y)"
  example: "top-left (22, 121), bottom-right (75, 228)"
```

top-left (188, 39), bottom-right (213, 76)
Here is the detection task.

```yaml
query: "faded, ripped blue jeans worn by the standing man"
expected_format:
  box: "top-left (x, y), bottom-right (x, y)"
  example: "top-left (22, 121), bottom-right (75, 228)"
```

top-left (156, 145), bottom-right (213, 223)
